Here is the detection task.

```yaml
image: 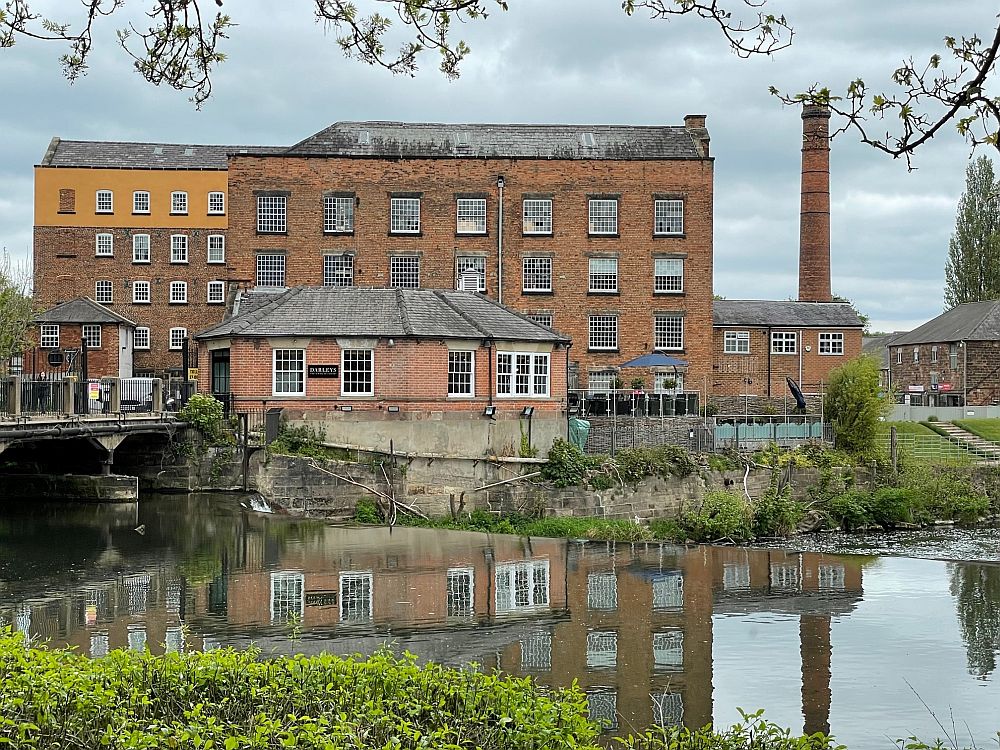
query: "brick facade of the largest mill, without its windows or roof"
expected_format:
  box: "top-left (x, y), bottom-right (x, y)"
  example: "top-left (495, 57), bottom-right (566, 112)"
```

top-left (229, 155), bottom-right (713, 394)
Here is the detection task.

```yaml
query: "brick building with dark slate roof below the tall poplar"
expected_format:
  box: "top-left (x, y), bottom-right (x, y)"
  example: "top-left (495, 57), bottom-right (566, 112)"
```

top-left (886, 300), bottom-right (1000, 406)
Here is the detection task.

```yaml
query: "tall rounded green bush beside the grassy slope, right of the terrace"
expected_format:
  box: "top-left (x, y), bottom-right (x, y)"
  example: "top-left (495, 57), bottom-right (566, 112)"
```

top-left (824, 356), bottom-right (890, 455)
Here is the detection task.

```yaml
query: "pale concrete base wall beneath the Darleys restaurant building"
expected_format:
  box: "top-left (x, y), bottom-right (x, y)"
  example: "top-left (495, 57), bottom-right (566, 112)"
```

top-left (285, 410), bottom-right (566, 458)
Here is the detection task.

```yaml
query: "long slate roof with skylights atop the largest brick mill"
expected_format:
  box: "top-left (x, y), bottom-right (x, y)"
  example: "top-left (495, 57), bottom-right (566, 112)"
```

top-left (286, 122), bottom-right (708, 159)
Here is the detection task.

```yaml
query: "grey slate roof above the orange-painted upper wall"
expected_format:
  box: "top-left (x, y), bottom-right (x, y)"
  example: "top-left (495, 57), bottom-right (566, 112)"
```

top-left (41, 138), bottom-right (286, 169)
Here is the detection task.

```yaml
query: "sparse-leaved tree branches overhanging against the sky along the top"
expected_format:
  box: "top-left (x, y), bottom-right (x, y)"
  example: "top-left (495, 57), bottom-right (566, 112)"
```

top-left (0, 0), bottom-right (1000, 163)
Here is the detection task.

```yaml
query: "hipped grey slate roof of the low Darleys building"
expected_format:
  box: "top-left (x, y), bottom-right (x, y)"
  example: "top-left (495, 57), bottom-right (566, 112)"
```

top-left (195, 286), bottom-right (569, 343)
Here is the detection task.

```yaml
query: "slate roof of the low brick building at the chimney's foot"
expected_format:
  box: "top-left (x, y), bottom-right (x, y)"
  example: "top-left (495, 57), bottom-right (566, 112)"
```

top-left (712, 299), bottom-right (864, 328)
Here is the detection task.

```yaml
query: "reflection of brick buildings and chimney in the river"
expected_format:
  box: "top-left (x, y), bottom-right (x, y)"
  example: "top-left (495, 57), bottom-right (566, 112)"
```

top-left (0, 500), bottom-right (864, 737)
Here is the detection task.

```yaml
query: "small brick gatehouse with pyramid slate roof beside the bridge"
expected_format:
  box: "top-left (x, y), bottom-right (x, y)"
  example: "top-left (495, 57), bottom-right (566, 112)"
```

top-left (21, 297), bottom-right (135, 379)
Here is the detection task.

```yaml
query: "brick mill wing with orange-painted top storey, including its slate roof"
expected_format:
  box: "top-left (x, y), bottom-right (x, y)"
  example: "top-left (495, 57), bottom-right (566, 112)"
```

top-left (34, 138), bottom-right (284, 376)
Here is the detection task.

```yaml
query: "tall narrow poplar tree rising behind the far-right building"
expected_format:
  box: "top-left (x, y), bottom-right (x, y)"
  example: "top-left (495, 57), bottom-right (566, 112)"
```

top-left (944, 156), bottom-right (1000, 308)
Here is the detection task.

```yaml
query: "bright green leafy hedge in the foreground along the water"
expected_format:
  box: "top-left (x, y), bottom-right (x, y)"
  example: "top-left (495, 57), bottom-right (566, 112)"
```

top-left (0, 629), bottom-right (597, 750)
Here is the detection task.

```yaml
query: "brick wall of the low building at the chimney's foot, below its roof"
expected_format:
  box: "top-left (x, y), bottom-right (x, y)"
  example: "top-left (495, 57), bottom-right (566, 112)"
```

top-left (712, 326), bottom-right (861, 398)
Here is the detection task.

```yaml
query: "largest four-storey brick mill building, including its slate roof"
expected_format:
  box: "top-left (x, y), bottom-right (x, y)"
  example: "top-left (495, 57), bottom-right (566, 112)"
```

top-left (229, 115), bottom-right (714, 388)
